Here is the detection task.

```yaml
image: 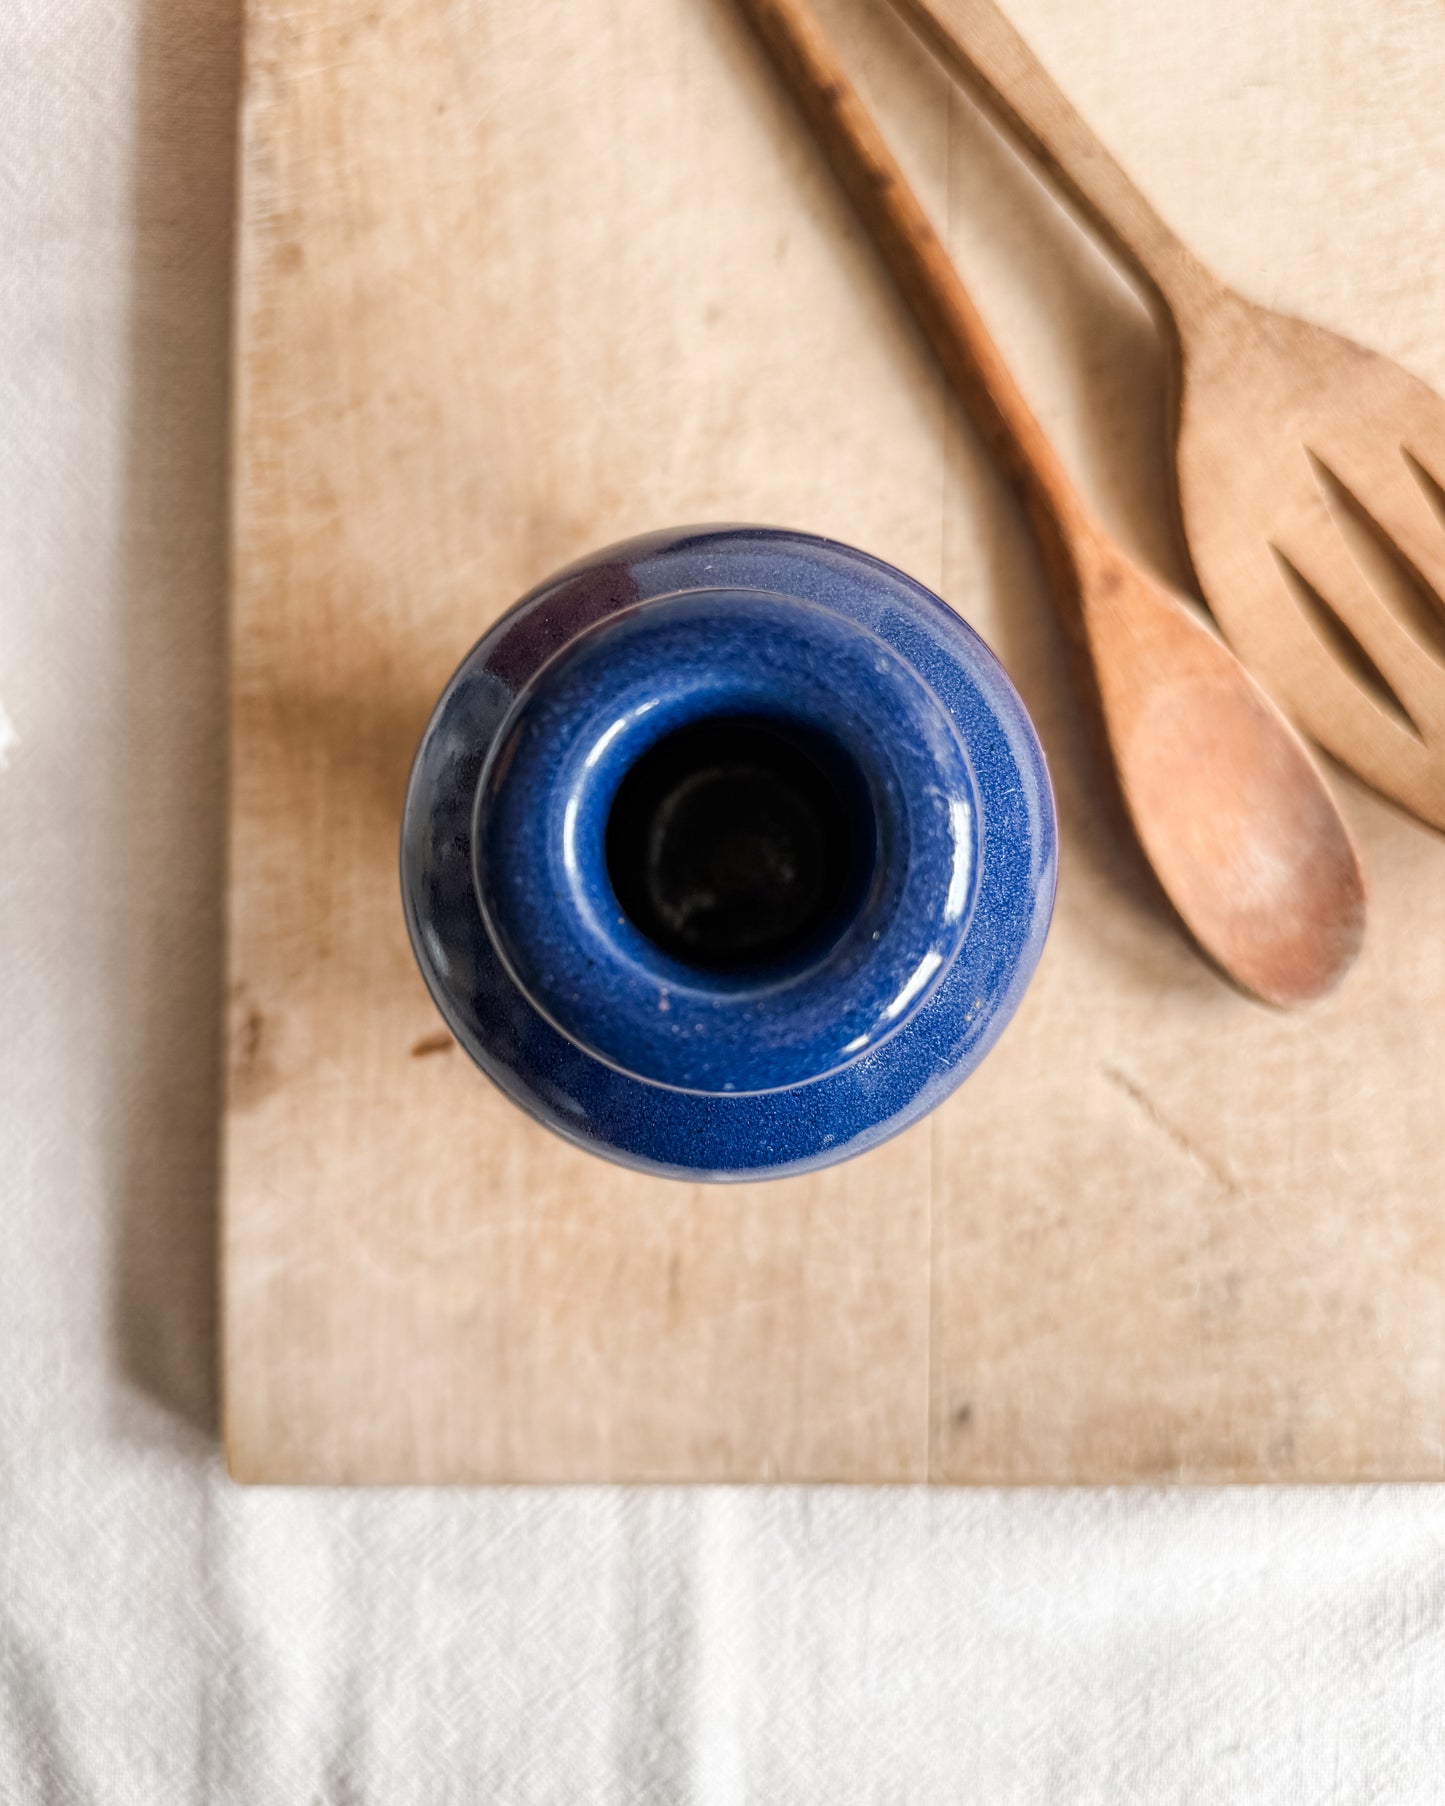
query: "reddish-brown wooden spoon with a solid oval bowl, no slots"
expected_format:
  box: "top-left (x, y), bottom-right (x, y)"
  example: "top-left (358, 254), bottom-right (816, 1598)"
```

top-left (741, 0), bottom-right (1366, 1004)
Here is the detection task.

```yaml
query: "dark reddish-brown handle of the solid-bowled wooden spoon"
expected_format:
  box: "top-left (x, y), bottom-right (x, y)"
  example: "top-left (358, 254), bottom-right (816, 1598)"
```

top-left (739, 0), bottom-right (1093, 563)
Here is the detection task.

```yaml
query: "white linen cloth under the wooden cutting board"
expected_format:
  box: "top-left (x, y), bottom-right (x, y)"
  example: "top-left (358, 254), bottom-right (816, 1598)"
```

top-left (0, 0), bottom-right (1445, 1806)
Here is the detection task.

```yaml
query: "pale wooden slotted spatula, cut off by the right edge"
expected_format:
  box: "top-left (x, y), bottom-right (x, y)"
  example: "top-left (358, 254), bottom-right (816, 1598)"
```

top-left (894, 0), bottom-right (1445, 827)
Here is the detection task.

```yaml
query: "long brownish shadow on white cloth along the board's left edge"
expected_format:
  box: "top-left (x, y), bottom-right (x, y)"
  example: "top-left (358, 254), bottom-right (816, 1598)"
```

top-left (107, 0), bottom-right (240, 1434)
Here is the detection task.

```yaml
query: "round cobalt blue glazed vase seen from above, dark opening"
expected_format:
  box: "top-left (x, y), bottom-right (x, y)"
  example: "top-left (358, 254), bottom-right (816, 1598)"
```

top-left (401, 527), bottom-right (1057, 1179)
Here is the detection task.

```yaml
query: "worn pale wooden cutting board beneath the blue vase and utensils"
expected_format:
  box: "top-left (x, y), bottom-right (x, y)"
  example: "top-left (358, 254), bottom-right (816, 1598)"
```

top-left (224, 0), bottom-right (1445, 1481)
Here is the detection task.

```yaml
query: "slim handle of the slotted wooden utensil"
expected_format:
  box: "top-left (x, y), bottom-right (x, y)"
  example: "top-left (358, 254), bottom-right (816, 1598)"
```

top-left (892, 0), bottom-right (1214, 311)
